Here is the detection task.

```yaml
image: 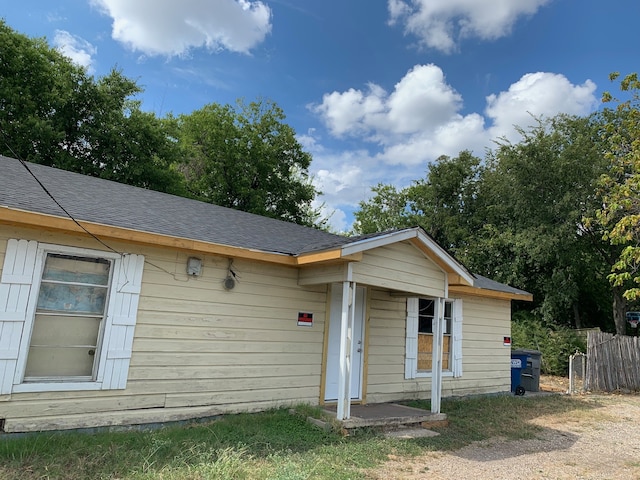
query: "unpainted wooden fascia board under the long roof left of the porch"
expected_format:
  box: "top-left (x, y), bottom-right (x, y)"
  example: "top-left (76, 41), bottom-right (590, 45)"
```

top-left (0, 206), bottom-right (297, 266)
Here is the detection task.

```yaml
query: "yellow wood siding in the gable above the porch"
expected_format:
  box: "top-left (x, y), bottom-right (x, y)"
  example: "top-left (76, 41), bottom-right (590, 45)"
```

top-left (353, 242), bottom-right (445, 297)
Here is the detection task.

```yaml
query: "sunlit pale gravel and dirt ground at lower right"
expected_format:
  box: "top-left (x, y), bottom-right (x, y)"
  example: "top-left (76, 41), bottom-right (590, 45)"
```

top-left (370, 377), bottom-right (640, 480)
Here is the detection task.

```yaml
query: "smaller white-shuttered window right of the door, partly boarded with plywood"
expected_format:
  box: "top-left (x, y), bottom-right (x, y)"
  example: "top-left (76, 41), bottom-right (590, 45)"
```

top-left (405, 298), bottom-right (462, 379)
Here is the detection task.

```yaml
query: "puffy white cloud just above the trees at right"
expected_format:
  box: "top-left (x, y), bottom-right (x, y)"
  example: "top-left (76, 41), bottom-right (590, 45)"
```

top-left (485, 72), bottom-right (598, 140)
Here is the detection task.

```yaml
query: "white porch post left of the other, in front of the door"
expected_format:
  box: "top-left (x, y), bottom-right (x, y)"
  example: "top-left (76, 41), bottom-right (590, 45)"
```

top-left (337, 281), bottom-right (356, 420)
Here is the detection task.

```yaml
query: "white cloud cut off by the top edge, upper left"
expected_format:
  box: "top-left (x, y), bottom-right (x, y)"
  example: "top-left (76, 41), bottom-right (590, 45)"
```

top-left (92, 0), bottom-right (271, 56)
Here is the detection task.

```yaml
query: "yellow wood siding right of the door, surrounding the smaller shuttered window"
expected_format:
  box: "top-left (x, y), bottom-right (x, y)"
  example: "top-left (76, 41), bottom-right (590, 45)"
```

top-left (367, 289), bottom-right (511, 403)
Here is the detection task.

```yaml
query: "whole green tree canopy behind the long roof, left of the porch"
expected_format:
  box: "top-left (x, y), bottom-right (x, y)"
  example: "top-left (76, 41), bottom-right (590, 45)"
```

top-left (0, 21), bottom-right (323, 227)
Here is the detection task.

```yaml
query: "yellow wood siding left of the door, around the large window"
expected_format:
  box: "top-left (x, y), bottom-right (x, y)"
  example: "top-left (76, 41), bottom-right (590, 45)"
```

top-left (0, 227), bottom-right (326, 432)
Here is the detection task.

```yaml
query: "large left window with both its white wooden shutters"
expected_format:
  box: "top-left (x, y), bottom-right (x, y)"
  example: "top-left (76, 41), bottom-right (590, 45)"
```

top-left (0, 240), bottom-right (144, 394)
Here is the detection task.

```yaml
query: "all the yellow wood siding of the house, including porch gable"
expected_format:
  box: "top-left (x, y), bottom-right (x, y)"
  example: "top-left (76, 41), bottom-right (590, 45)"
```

top-left (0, 226), bottom-right (510, 431)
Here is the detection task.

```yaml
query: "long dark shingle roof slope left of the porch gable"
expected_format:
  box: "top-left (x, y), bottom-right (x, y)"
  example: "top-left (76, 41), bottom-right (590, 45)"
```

top-left (0, 156), bottom-right (352, 255)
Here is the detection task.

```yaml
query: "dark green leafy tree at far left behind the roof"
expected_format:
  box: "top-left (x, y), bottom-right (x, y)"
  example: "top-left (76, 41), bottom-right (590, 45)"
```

top-left (0, 21), bottom-right (183, 193)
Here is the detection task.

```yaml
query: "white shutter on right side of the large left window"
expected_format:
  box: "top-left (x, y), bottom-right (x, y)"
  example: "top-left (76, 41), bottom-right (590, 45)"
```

top-left (98, 255), bottom-right (144, 390)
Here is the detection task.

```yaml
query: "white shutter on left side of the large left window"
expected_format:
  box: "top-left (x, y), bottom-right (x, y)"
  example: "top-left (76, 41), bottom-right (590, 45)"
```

top-left (0, 239), bottom-right (38, 395)
